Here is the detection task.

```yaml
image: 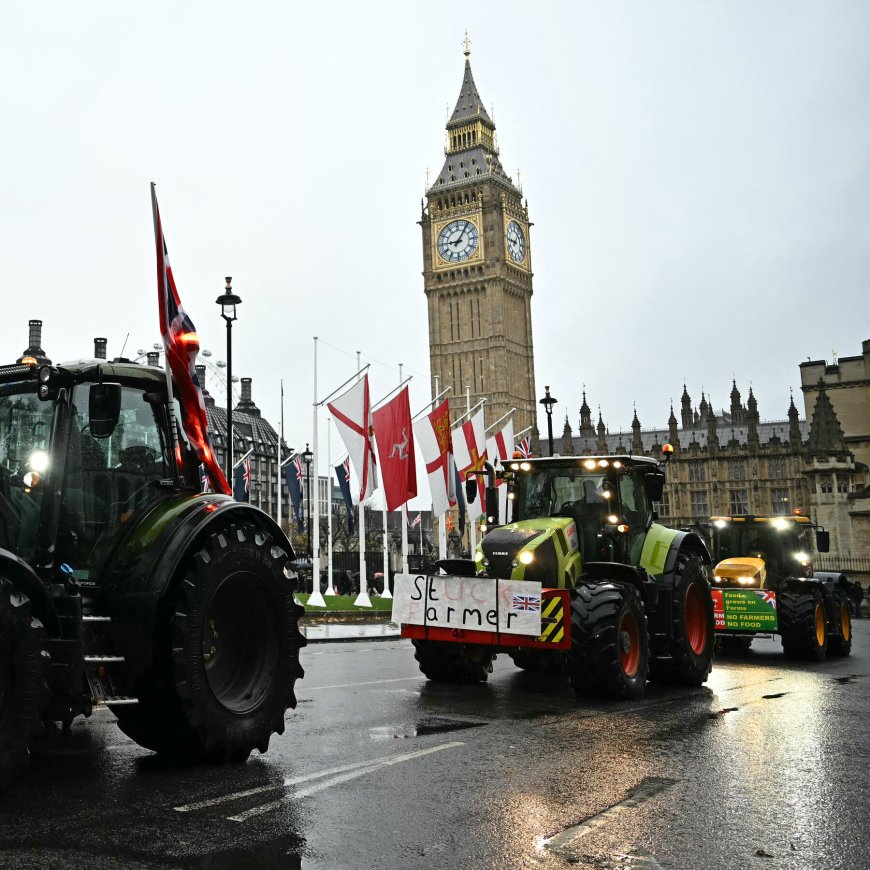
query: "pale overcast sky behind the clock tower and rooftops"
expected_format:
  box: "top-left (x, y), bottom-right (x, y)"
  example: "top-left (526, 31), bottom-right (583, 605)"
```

top-left (0, 0), bottom-right (870, 490)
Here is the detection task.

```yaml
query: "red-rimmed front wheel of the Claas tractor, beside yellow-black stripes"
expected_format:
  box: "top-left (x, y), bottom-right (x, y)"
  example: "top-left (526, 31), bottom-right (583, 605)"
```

top-left (567, 583), bottom-right (649, 700)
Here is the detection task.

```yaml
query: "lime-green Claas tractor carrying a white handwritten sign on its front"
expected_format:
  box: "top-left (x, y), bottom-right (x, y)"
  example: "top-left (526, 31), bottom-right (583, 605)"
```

top-left (394, 455), bottom-right (713, 699)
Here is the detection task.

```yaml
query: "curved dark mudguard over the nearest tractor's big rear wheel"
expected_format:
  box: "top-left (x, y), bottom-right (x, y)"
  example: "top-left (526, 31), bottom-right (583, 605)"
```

top-left (101, 493), bottom-right (294, 694)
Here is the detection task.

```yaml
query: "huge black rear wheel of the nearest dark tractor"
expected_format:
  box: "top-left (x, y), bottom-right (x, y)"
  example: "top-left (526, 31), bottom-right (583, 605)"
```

top-left (114, 525), bottom-right (305, 762)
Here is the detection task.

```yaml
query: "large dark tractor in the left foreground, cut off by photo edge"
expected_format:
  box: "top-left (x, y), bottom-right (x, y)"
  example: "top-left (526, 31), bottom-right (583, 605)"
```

top-left (0, 358), bottom-right (305, 787)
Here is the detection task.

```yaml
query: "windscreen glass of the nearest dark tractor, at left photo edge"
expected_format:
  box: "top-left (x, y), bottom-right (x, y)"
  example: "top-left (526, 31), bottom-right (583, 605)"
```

top-left (0, 383), bottom-right (52, 559)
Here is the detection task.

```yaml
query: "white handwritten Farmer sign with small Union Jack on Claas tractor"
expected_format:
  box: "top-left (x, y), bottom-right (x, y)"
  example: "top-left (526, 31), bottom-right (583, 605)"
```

top-left (393, 574), bottom-right (541, 637)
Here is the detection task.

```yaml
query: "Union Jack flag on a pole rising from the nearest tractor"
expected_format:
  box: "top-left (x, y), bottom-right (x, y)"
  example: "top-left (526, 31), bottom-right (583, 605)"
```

top-left (151, 184), bottom-right (230, 495)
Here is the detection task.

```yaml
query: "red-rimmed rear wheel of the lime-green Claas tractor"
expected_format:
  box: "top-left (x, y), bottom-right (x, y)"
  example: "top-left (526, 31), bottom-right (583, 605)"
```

top-left (650, 553), bottom-right (714, 686)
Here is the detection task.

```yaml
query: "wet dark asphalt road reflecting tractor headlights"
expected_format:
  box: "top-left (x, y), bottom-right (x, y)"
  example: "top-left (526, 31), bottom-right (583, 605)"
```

top-left (0, 620), bottom-right (870, 870)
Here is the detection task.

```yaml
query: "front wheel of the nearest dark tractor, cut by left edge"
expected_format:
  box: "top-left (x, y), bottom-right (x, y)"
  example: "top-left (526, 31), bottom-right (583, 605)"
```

top-left (0, 577), bottom-right (48, 791)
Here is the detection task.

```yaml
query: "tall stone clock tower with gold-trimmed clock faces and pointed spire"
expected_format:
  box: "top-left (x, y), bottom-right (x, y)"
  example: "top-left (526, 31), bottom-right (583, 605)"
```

top-left (420, 43), bottom-right (536, 432)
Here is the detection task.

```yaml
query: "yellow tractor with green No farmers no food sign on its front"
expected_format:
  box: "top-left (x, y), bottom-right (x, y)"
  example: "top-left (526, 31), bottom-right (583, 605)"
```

top-left (712, 514), bottom-right (852, 661)
